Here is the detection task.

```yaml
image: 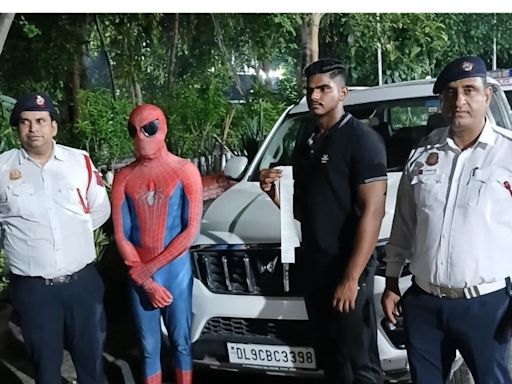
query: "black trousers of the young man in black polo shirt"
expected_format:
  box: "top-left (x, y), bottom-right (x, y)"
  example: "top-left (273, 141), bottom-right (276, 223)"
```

top-left (304, 262), bottom-right (382, 384)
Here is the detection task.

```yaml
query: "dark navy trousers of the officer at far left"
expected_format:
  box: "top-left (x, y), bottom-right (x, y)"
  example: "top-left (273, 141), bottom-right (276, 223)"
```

top-left (10, 264), bottom-right (106, 384)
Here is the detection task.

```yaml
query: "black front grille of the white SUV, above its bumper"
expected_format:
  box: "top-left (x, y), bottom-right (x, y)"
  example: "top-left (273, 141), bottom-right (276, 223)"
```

top-left (192, 244), bottom-right (300, 296)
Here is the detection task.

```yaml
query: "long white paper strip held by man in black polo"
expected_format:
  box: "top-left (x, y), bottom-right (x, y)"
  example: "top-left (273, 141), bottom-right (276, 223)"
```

top-left (276, 166), bottom-right (300, 263)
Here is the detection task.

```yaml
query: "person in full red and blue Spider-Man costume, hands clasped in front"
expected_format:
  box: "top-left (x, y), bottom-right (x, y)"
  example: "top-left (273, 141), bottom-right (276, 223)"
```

top-left (112, 104), bottom-right (203, 384)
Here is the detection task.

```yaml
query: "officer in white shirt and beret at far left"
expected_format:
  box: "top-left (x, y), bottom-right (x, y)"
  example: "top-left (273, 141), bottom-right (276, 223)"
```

top-left (0, 93), bottom-right (110, 384)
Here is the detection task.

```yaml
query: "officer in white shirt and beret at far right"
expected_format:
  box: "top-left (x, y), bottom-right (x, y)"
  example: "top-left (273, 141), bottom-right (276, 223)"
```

top-left (382, 56), bottom-right (512, 384)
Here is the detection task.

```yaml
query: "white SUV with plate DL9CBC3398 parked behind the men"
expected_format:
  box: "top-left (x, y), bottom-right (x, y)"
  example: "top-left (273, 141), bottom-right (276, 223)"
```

top-left (172, 78), bottom-right (512, 379)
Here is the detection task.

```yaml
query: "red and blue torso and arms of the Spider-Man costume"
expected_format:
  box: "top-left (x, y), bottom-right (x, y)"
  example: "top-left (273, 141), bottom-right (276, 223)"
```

top-left (117, 158), bottom-right (202, 272)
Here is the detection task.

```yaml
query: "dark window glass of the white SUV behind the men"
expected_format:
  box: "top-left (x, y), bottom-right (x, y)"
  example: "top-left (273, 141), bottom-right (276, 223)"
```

top-left (250, 87), bottom-right (511, 181)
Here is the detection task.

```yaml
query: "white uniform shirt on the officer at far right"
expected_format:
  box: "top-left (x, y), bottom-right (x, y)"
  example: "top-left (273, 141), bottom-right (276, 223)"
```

top-left (386, 122), bottom-right (512, 288)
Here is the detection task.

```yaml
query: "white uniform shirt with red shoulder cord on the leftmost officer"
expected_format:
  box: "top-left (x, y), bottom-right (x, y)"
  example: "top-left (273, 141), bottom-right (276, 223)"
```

top-left (0, 142), bottom-right (110, 278)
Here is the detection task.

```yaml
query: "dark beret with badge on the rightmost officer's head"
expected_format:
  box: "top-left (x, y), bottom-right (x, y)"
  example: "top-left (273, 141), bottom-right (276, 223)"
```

top-left (434, 56), bottom-right (487, 94)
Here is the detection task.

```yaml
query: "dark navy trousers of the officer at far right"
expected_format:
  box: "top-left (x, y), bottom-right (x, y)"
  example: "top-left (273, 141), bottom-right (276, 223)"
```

top-left (402, 284), bottom-right (512, 384)
